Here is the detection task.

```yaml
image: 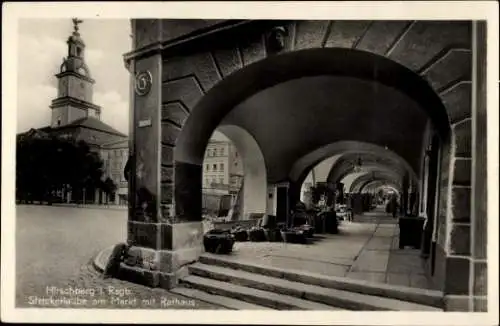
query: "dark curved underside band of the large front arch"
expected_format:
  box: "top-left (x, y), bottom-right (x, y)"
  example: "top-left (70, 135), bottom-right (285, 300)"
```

top-left (174, 48), bottom-right (450, 164)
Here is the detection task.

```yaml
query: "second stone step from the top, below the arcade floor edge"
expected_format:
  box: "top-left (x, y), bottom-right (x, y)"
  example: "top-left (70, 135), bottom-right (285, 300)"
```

top-left (189, 263), bottom-right (439, 311)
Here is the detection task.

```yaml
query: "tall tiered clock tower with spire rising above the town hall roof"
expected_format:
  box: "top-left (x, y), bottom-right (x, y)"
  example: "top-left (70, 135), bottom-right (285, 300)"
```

top-left (50, 18), bottom-right (101, 128)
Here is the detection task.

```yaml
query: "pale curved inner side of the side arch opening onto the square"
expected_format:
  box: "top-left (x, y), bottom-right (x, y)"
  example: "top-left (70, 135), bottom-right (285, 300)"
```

top-left (217, 125), bottom-right (267, 219)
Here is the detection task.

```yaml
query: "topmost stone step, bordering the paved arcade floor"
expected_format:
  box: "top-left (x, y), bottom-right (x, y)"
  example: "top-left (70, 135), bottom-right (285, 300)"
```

top-left (199, 253), bottom-right (443, 309)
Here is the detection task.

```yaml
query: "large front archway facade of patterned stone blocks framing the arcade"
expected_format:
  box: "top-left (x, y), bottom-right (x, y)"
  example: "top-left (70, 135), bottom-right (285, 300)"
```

top-left (126, 19), bottom-right (482, 298)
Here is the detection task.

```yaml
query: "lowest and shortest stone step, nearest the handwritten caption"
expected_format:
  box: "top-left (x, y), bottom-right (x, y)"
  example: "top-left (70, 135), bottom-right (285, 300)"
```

top-left (170, 287), bottom-right (273, 310)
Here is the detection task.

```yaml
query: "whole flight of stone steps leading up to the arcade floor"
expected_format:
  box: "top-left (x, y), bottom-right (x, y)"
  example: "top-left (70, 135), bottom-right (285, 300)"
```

top-left (171, 254), bottom-right (443, 311)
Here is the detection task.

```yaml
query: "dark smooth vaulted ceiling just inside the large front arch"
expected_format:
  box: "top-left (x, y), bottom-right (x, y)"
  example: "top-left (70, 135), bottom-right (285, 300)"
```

top-left (222, 76), bottom-right (428, 182)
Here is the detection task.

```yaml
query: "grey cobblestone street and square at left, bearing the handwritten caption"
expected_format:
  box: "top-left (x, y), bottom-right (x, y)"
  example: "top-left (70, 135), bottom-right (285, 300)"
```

top-left (16, 205), bottom-right (221, 309)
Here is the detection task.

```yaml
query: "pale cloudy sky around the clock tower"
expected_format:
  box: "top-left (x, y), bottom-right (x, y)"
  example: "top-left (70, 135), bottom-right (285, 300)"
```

top-left (17, 18), bottom-right (225, 139)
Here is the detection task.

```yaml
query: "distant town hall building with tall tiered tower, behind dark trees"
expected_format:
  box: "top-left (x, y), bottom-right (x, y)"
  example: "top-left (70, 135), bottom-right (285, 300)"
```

top-left (18, 21), bottom-right (128, 204)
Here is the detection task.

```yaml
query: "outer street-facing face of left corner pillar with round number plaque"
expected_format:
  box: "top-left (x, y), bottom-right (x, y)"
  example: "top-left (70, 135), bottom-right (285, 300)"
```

top-left (115, 19), bottom-right (174, 288)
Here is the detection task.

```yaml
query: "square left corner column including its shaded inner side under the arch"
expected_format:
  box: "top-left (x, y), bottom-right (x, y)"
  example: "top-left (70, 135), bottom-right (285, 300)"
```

top-left (118, 19), bottom-right (203, 289)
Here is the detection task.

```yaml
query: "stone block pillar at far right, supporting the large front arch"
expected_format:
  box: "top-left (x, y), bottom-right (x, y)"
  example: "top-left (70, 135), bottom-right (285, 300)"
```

top-left (444, 21), bottom-right (487, 311)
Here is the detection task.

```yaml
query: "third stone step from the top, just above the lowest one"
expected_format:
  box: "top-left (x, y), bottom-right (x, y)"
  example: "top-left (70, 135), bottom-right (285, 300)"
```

top-left (181, 275), bottom-right (341, 310)
